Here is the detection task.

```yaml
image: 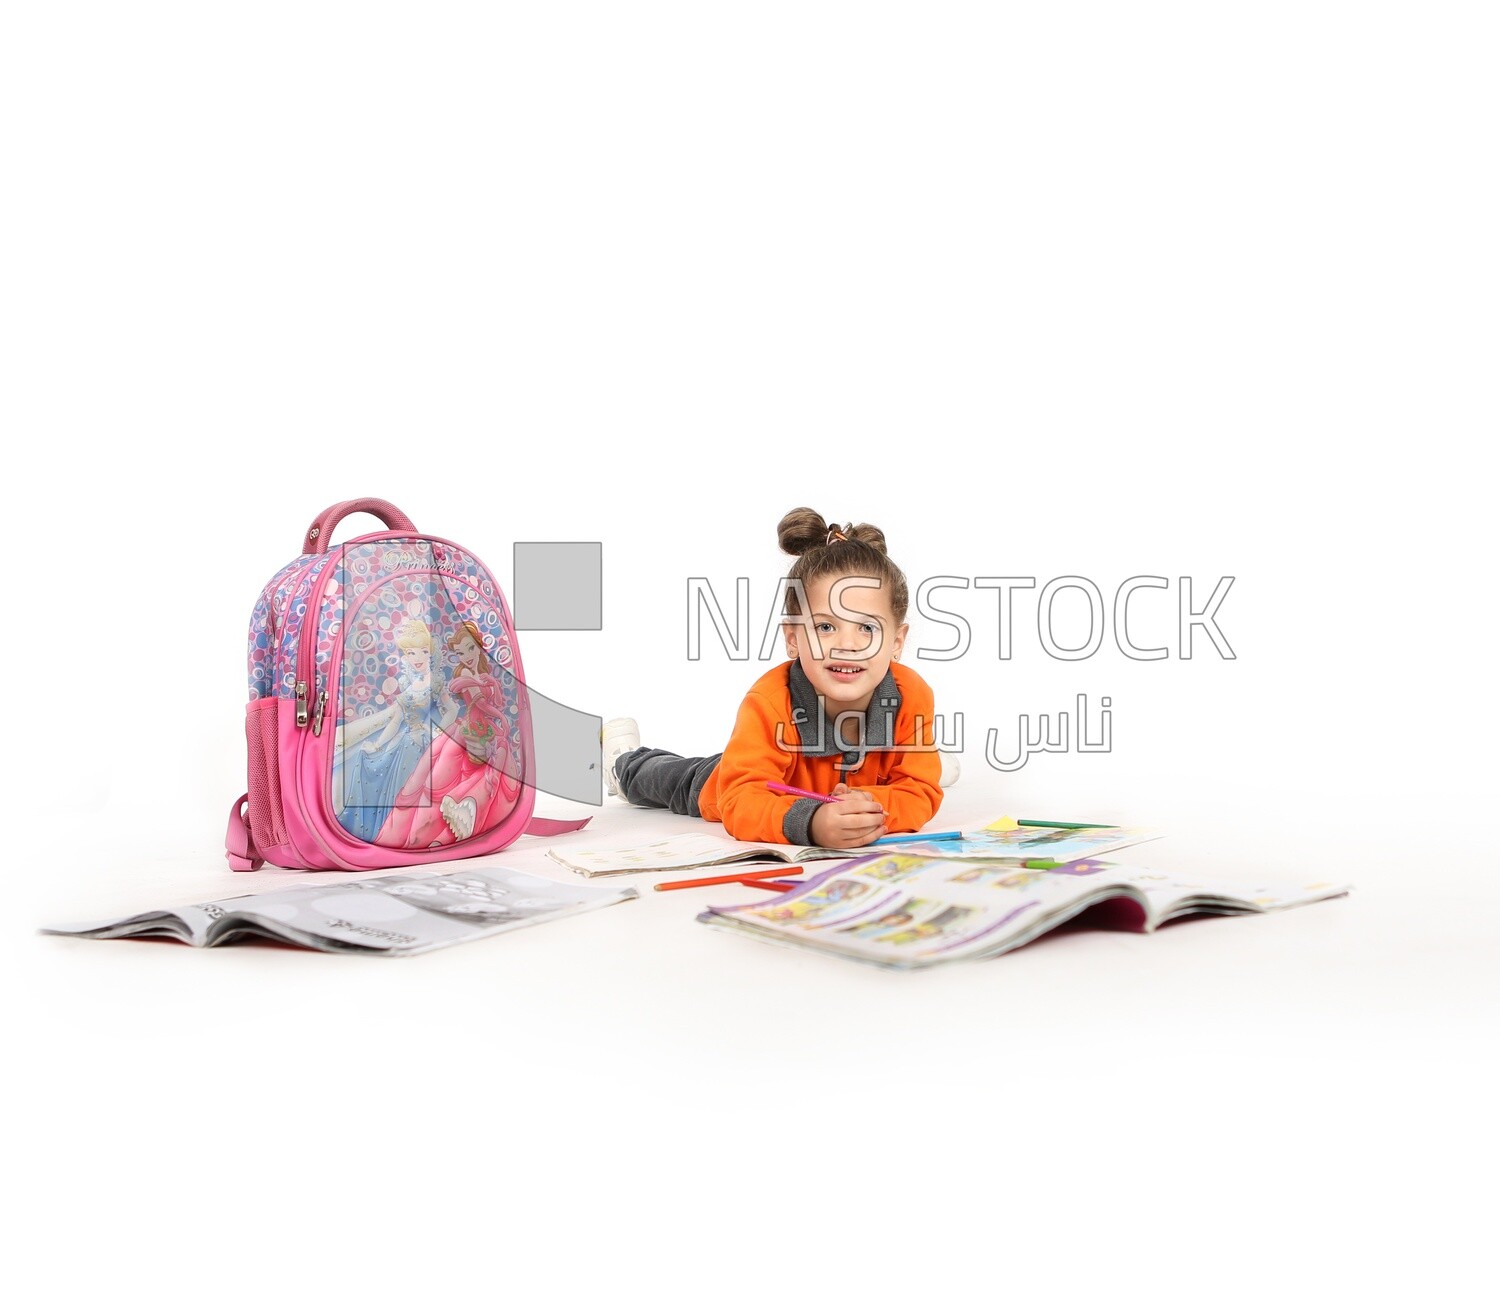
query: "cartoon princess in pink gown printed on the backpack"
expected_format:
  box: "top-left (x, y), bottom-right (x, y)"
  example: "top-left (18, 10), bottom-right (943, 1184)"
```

top-left (375, 623), bottom-right (521, 848)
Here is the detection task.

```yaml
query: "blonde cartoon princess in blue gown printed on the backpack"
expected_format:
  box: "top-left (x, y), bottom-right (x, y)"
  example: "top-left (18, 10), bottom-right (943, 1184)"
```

top-left (339, 620), bottom-right (458, 842)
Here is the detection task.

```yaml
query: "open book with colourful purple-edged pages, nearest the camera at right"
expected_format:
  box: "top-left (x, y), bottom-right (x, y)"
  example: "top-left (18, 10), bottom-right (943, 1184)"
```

top-left (698, 854), bottom-right (1349, 969)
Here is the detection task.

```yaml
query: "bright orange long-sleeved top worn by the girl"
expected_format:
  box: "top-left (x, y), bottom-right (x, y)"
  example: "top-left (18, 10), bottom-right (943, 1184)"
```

top-left (698, 660), bottom-right (942, 846)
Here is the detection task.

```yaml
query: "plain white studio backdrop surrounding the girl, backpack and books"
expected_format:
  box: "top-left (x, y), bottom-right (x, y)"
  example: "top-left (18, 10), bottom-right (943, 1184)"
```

top-left (0, 0), bottom-right (1500, 1307)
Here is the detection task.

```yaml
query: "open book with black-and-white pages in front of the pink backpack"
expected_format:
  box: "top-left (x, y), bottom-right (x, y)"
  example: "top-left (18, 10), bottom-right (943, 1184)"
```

top-left (42, 869), bottom-right (636, 956)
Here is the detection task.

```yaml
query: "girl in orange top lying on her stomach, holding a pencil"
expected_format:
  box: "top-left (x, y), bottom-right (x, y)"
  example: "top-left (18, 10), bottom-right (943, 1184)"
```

top-left (603, 506), bottom-right (944, 848)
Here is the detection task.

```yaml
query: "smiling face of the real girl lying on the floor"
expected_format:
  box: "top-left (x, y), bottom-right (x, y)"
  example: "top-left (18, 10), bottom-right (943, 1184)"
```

top-left (782, 578), bottom-right (908, 716)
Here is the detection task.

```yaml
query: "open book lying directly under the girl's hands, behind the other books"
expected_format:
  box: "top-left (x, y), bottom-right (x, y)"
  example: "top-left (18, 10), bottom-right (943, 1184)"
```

top-left (548, 828), bottom-right (1161, 878)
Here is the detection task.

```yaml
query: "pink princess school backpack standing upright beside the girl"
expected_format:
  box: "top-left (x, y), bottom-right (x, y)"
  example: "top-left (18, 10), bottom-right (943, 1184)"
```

top-left (225, 498), bottom-right (588, 870)
